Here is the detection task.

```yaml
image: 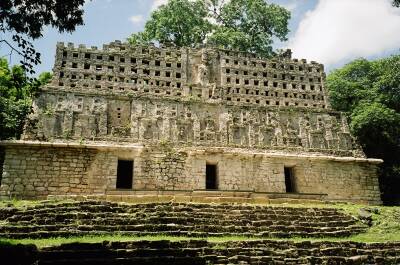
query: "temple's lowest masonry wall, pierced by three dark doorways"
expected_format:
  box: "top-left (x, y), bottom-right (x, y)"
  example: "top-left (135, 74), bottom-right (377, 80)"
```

top-left (0, 142), bottom-right (380, 203)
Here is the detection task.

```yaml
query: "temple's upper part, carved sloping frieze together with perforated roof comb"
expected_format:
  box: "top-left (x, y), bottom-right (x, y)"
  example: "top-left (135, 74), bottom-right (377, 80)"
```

top-left (21, 43), bottom-right (362, 156)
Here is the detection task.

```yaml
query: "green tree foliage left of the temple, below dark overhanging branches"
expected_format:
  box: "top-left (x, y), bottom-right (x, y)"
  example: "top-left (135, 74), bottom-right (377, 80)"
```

top-left (0, 59), bottom-right (51, 140)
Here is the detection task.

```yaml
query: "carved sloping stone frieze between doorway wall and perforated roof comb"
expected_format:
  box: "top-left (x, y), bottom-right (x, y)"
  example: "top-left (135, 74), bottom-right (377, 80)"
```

top-left (24, 91), bottom-right (364, 157)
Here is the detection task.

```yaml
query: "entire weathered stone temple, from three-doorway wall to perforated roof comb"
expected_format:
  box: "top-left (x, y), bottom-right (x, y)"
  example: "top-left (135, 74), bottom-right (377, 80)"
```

top-left (0, 41), bottom-right (382, 204)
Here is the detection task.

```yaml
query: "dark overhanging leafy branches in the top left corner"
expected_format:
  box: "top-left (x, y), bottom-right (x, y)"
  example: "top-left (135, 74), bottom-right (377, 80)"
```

top-left (0, 0), bottom-right (85, 73)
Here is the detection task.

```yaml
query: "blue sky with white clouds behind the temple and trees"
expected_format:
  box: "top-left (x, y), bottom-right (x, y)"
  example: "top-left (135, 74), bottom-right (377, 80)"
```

top-left (0, 0), bottom-right (400, 73)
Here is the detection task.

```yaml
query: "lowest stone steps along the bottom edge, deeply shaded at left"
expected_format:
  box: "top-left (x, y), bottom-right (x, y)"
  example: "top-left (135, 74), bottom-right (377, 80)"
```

top-left (0, 240), bottom-right (400, 265)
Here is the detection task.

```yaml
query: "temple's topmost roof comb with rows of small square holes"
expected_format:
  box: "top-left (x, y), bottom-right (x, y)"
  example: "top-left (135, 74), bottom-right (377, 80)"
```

top-left (51, 41), bottom-right (330, 109)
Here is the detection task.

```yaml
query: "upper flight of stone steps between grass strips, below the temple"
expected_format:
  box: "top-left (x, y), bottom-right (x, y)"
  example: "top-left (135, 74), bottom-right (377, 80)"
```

top-left (0, 201), bottom-right (366, 238)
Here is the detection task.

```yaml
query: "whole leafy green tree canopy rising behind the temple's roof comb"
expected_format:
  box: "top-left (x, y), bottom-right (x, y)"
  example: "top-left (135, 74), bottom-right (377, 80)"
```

top-left (128, 0), bottom-right (290, 57)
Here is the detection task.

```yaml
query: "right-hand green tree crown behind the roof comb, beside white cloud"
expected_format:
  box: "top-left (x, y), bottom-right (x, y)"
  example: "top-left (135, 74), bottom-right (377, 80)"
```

top-left (208, 0), bottom-right (290, 56)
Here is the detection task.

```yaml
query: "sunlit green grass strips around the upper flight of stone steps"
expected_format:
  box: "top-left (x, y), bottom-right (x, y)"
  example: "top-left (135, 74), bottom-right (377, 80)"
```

top-left (0, 200), bottom-right (400, 248)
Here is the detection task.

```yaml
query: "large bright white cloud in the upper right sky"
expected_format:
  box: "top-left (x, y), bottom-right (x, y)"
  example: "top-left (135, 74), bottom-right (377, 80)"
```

top-left (289, 0), bottom-right (400, 65)
